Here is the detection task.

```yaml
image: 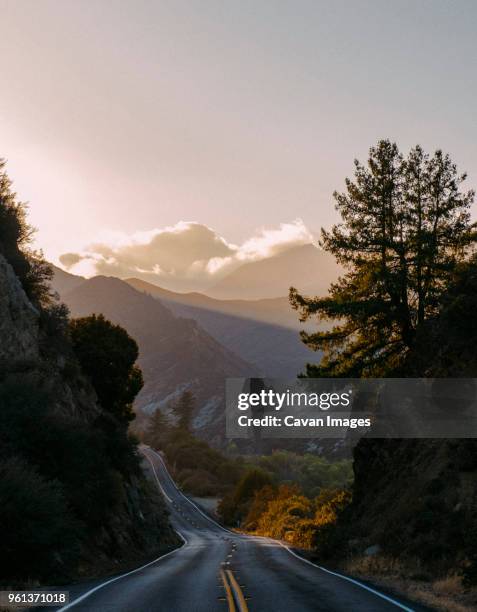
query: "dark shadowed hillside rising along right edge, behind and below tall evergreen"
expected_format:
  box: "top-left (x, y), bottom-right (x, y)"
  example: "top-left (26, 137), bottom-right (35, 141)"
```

top-left (330, 268), bottom-right (477, 586)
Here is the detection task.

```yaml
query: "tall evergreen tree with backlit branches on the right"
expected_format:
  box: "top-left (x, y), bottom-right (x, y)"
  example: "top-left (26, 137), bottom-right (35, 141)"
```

top-left (290, 140), bottom-right (476, 376)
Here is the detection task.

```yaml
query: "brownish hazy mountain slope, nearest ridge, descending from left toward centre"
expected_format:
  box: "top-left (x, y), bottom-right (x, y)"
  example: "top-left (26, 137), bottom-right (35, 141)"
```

top-left (62, 276), bottom-right (258, 443)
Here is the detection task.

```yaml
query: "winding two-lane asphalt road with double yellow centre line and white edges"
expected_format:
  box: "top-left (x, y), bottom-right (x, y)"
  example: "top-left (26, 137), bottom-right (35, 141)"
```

top-left (56, 447), bottom-right (428, 612)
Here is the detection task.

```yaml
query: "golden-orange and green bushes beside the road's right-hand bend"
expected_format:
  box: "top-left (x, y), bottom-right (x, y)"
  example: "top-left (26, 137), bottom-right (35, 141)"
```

top-left (217, 451), bottom-right (352, 547)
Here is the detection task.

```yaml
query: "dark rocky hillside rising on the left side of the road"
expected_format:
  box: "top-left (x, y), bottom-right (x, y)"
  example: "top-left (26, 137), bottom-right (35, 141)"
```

top-left (0, 255), bottom-right (177, 585)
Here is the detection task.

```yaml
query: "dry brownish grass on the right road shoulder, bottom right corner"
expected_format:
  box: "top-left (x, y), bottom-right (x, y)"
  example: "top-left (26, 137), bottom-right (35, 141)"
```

top-left (343, 555), bottom-right (477, 612)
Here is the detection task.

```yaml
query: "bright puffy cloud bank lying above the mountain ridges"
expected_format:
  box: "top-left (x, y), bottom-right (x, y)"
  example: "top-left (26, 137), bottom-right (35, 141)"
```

top-left (60, 219), bottom-right (313, 290)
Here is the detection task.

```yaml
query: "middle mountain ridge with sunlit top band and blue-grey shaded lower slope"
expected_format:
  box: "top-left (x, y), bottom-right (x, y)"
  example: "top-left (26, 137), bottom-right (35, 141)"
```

top-left (127, 279), bottom-right (318, 378)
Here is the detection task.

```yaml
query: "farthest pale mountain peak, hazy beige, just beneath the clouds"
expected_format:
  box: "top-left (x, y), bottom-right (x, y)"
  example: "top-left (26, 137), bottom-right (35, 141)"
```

top-left (206, 244), bottom-right (341, 300)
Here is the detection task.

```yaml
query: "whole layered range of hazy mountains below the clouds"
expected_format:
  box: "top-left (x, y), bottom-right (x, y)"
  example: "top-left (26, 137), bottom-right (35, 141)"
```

top-left (52, 245), bottom-right (339, 444)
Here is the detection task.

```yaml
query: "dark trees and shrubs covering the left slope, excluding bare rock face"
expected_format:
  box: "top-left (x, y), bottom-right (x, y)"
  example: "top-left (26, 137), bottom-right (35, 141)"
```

top-left (0, 161), bottom-right (167, 585)
